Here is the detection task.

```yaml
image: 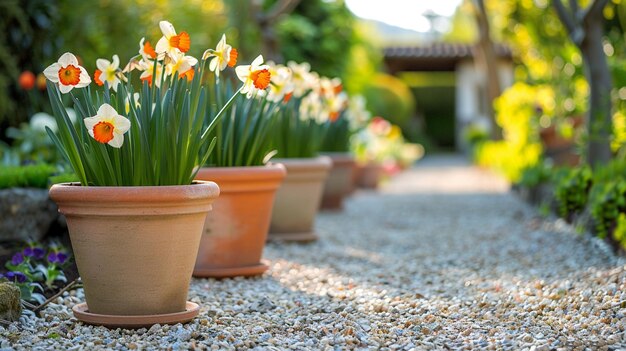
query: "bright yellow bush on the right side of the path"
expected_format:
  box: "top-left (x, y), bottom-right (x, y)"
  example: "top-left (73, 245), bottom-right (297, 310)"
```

top-left (475, 83), bottom-right (555, 182)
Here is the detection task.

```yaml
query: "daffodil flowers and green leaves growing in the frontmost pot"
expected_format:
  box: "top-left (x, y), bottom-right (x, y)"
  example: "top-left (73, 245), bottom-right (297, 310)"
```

top-left (45, 21), bottom-right (269, 186)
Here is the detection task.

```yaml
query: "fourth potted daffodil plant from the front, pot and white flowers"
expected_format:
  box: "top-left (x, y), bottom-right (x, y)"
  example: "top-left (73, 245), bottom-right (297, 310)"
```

top-left (322, 93), bottom-right (370, 210)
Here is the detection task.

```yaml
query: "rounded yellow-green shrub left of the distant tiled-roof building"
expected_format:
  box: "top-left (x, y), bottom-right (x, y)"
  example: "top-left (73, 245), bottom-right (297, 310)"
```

top-left (363, 73), bottom-right (415, 128)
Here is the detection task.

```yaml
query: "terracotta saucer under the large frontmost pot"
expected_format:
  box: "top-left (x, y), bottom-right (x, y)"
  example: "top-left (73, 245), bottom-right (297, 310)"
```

top-left (72, 301), bottom-right (200, 329)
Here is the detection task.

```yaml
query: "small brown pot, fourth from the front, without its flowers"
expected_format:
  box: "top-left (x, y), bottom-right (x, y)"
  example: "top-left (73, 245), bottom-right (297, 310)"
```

top-left (322, 152), bottom-right (356, 210)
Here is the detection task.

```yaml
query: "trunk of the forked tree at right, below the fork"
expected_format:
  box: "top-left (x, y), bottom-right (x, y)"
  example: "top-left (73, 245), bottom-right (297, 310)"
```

top-left (580, 17), bottom-right (613, 169)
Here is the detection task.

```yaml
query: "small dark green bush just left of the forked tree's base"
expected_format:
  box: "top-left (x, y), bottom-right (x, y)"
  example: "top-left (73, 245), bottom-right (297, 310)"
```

top-left (555, 166), bottom-right (592, 223)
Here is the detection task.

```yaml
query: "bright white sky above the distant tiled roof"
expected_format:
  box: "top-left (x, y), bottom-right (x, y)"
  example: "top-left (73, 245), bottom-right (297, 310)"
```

top-left (345, 0), bottom-right (462, 32)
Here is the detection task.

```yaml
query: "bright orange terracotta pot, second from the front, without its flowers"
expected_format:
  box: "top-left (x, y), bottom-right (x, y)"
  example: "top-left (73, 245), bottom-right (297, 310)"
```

top-left (193, 164), bottom-right (287, 278)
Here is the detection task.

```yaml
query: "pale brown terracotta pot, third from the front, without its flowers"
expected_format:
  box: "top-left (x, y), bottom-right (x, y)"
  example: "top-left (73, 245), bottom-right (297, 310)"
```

top-left (269, 156), bottom-right (332, 241)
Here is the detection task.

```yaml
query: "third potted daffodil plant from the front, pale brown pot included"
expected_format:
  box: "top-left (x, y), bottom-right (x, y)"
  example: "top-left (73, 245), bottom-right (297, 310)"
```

top-left (269, 62), bottom-right (332, 241)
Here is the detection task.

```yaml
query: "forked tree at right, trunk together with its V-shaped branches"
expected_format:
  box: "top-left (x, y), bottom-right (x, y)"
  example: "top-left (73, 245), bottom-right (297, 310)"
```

top-left (552, 0), bottom-right (612, 168)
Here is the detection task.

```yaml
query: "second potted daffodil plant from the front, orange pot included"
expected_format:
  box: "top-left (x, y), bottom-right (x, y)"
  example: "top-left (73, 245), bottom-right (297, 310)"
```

top-left (193, 44), bottom-right (286, 278)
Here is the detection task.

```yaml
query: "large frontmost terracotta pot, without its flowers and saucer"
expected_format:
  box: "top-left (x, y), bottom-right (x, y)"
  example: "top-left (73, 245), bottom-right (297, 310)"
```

top-left (50, 182), bottom-right (219, 325)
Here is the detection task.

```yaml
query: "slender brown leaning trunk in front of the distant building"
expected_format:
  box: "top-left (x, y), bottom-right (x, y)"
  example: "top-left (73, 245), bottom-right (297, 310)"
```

top-left (475, 0), bottom-right (502, 140)
